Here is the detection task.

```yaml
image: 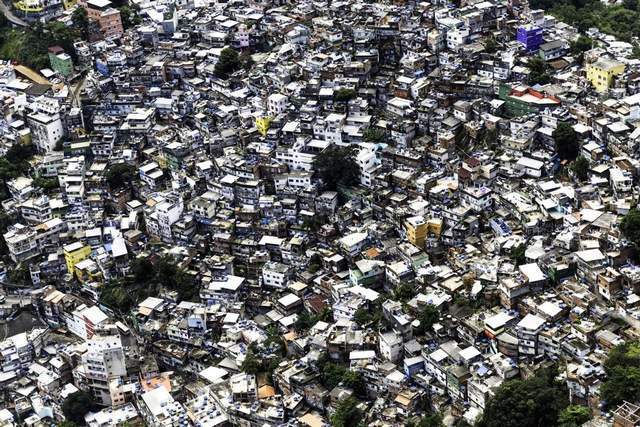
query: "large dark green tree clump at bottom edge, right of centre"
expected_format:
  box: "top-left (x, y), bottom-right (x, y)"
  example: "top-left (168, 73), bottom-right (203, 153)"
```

top-left (478, 370), bottom-right (569, 427)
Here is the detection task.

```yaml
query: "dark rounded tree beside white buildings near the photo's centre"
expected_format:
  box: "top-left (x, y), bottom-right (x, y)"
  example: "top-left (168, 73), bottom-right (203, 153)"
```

top-left (313, 146), bottom-right (360, 190)
